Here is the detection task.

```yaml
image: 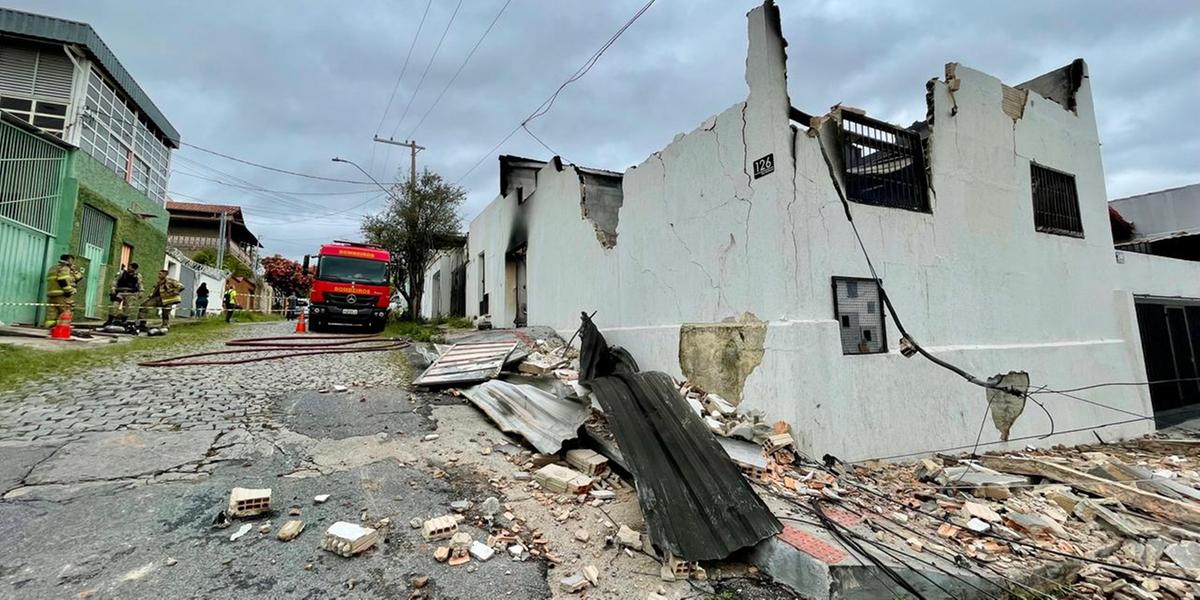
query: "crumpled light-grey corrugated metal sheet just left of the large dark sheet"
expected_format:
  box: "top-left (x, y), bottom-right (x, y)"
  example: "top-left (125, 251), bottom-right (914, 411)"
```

top-left (461, 379), bottom-right (592, 454)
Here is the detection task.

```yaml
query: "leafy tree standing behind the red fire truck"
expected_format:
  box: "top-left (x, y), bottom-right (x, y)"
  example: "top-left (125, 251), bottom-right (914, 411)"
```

top-left (361, 169), bottom-right (467, 318)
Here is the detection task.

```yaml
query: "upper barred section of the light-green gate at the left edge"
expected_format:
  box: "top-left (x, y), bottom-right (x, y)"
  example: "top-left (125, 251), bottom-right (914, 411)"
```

top-left (0, 115), bottom-right (67, 234)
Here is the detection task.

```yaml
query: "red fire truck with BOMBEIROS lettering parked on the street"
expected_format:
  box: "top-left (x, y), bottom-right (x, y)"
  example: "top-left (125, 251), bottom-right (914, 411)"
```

top-left (304, 240), bottom-right (391, 331)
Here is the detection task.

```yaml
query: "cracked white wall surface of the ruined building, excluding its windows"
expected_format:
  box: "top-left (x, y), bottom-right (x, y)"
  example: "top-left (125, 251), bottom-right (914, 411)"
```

top-left (444, 0), bottom-right (1200, 460)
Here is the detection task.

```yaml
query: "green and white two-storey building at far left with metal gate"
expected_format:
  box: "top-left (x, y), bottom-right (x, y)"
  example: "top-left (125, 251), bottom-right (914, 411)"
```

top-left (0, 8), bottom-right (180, 323)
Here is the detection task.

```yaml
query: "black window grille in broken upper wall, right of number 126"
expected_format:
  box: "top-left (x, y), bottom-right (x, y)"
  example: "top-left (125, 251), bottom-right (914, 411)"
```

top-left (841, 112), bottom-right (929, 212)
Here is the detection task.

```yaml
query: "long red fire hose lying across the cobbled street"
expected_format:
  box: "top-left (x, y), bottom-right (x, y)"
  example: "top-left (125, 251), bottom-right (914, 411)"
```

top-left (138, 335), bottom-right (408, 367)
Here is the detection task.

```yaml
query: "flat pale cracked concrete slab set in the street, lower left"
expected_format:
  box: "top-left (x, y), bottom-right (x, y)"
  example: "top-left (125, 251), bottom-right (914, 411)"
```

top-left (25, 431), bottom-right (217, 484)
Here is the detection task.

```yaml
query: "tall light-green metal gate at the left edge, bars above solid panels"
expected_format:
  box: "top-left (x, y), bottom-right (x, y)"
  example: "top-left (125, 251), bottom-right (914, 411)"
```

top-left (0, 115), bottom-right (67, 324)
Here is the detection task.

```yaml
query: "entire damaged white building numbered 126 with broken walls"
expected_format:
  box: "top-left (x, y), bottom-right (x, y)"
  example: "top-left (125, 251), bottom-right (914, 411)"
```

top-left (426, 1), bottom-right (1200, 461)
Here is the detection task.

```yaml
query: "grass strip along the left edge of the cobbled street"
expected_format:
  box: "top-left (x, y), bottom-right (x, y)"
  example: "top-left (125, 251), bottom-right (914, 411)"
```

top-left (0, 313), bottom-right (281, 391)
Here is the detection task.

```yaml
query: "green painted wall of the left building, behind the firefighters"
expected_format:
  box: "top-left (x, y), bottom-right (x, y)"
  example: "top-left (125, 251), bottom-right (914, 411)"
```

top-left (66, 150), bottom-right (168, 298)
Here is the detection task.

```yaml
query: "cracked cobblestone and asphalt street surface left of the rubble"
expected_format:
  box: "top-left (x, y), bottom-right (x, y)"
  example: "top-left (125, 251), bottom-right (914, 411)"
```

top-left (0, 323), bottom-right (553, 599)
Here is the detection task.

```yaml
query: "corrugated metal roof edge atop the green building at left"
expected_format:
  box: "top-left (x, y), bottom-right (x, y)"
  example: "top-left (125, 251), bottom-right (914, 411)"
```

top-left (0, 8), bottom-right (179, 148)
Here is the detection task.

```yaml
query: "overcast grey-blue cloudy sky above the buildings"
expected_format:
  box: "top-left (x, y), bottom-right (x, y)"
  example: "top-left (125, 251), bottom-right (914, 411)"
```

top-left (0, 0), bottom-right (1200, 257)
